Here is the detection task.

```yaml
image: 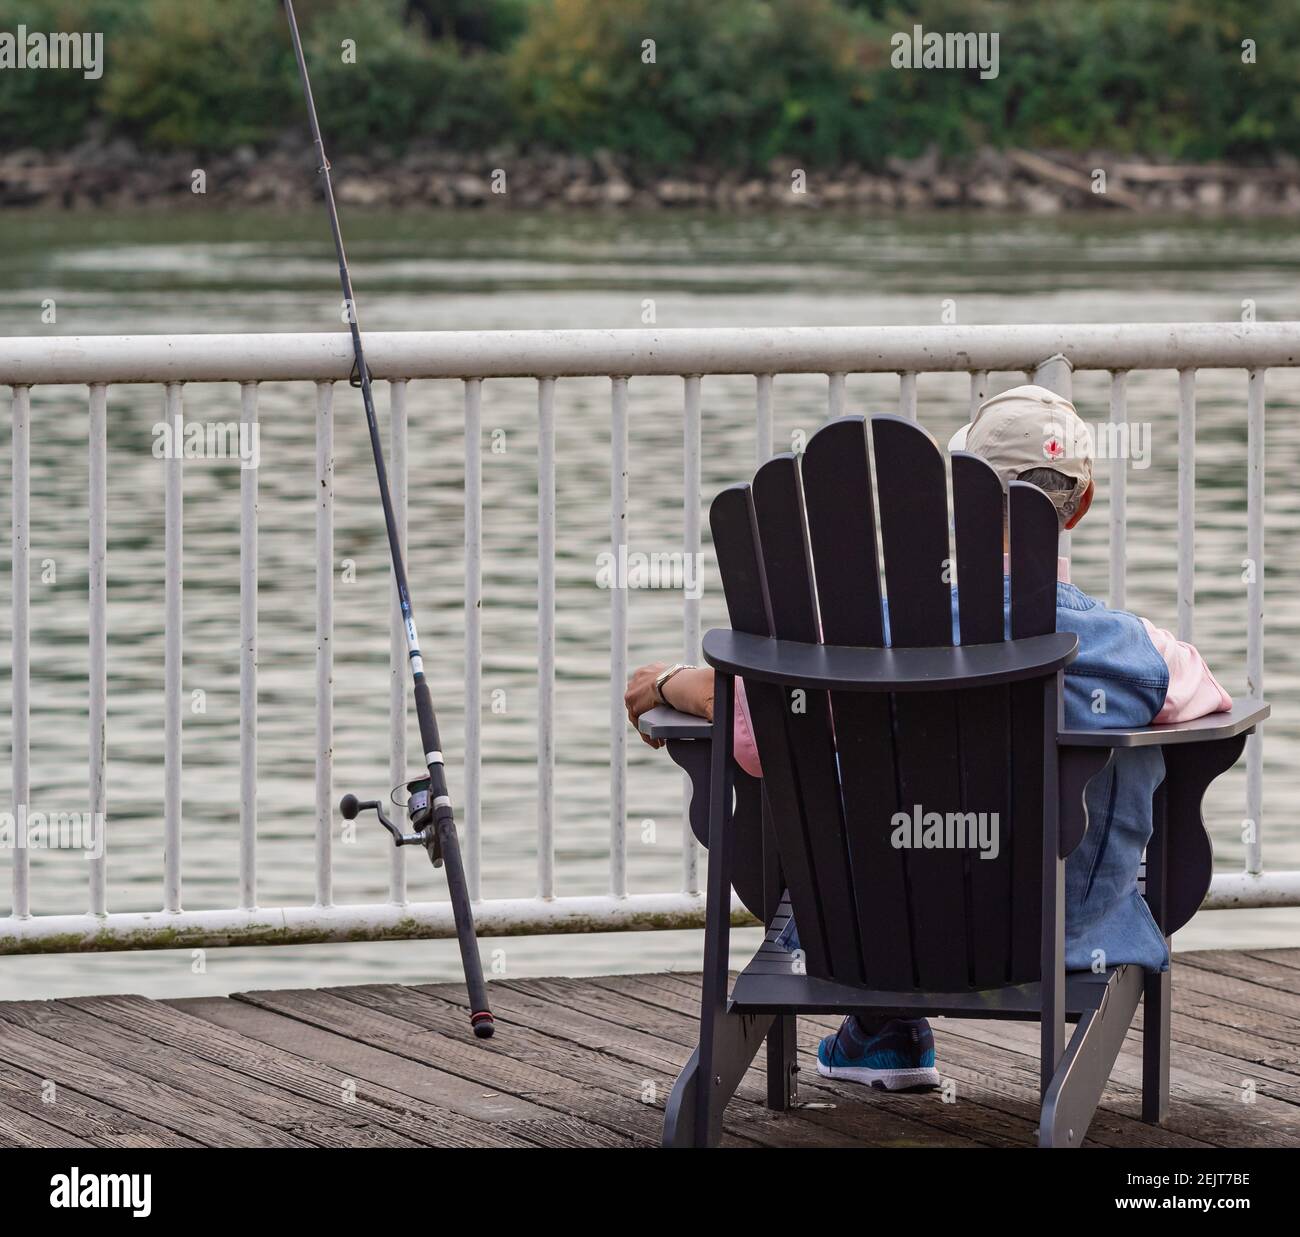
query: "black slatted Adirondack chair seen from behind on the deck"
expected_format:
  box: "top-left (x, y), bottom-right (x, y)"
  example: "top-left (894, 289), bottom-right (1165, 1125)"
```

top-left (641, 416), bottom-right (1269, 1146)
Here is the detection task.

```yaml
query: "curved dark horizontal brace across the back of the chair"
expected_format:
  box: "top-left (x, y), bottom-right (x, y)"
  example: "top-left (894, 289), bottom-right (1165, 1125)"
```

top-left (703, 628), bottom-right (1079, 691)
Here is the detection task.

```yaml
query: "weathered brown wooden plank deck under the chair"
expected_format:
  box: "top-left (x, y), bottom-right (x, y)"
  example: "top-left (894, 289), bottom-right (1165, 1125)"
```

top-left (0, 950), bottom-right (1300, 1147)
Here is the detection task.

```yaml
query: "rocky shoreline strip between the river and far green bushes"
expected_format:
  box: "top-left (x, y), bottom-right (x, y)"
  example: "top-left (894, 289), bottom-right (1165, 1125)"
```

top-left (0, 140), bottom-right (1300, 216)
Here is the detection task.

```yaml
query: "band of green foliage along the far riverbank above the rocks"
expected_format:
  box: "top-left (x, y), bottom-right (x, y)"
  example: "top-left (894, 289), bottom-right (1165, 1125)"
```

top-left (0, 0), bottom-right (1300, 170)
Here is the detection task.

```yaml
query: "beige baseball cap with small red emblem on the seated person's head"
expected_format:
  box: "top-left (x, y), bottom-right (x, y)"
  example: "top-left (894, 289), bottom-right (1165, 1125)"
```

top-left (948, 386), bottom-right (1092, 520)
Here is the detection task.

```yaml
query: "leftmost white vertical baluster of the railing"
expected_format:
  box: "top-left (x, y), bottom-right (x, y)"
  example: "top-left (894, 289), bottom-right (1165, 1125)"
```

top-left (12, 386), bottom-right (31, 919)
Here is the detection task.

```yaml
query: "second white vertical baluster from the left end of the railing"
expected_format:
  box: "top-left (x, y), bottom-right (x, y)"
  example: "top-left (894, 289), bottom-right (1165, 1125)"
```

top-left (87, 382), bottom-right (108, 915)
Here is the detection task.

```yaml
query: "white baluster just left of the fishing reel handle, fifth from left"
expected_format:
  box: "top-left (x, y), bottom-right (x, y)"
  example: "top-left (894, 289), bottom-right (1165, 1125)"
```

top-left (316, 382), bottom-right (334, 906)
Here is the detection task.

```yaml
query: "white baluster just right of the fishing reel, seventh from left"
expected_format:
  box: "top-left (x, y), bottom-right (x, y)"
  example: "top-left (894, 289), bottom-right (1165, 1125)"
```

top-left (462, 378), bottom-right (484, 902)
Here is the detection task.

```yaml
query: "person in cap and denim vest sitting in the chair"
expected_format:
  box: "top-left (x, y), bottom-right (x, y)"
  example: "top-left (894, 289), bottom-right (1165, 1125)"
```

top-left (624, 386), bottom-right (1232, 1090)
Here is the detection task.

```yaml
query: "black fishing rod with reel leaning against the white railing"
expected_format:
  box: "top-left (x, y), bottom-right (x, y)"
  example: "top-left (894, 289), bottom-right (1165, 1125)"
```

top-left (285, 0), bottom-right (495, 1039)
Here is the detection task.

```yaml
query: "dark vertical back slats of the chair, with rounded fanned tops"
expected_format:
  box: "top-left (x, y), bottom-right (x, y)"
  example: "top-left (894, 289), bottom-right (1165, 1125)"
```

top-left (710, 416), bottom-right (1057, 990)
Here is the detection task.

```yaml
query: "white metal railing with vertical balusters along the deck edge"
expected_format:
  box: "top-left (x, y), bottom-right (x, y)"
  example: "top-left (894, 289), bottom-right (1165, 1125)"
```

top-left (0, 322), bottom-right (1300, 952)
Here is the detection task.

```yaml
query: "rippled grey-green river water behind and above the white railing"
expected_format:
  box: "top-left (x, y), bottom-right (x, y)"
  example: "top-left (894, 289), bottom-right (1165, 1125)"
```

top-left (0, 205), bottom-right (1300, 998)
